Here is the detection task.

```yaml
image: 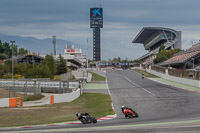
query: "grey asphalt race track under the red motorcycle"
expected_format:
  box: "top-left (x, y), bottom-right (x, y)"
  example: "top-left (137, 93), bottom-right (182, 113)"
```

top-left (1, 70), bottom-right (200, 133)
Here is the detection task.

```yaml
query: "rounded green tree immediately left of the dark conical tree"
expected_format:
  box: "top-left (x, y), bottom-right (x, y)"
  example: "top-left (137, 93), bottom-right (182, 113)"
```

top-left (43, 54), bottom-right (56, 76)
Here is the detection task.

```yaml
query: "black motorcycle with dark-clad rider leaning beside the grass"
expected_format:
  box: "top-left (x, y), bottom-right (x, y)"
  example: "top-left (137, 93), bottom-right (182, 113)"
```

top-left (76, 113), bottom-right (97, 124)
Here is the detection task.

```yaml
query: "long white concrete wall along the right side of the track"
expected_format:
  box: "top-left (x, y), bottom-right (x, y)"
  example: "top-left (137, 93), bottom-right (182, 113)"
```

top-left (146, 69), bottom-right (200, 87)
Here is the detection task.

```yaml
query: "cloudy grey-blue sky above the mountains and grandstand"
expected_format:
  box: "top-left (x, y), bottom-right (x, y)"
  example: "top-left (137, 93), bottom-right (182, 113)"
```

top-left (0, 0), bottom-right (200, 59)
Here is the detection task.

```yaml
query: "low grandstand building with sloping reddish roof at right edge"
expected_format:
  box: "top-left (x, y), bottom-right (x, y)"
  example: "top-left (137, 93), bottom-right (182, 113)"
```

top-left (160, 43), bottom-right (200, 69)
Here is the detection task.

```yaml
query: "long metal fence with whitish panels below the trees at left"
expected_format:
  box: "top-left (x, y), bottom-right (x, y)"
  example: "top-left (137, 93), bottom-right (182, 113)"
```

top-left (0, 80), bottom-right (79, 98)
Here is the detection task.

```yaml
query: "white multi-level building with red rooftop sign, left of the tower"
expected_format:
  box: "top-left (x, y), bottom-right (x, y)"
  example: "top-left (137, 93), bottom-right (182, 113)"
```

top-left (56, 45), bottom-right (87, 69)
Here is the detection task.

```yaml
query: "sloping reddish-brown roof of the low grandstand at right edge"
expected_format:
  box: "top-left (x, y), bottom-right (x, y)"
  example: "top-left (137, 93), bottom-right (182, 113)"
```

top-left (160, 44), bottom-right (200, 66)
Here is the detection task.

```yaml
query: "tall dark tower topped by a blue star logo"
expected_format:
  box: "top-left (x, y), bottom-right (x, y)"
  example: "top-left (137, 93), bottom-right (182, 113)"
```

top-left (90, 8), bottom-right (103, 61)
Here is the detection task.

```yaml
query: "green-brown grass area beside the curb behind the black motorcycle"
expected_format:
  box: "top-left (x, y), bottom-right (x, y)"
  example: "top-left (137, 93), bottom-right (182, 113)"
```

top-left (0, 93), bottom-right (114, 127)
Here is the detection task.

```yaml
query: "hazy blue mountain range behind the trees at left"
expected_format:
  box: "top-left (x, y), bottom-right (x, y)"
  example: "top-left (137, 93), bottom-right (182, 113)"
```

top-left (0, 33), bottom-right (91, 55)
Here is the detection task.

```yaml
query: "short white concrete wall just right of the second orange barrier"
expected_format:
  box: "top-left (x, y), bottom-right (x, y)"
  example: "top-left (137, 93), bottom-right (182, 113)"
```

top-left (53, 89), bottom-right (80, 103)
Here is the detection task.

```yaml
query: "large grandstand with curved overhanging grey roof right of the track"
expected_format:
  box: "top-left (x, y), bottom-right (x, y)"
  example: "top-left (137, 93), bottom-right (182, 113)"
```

top-left (132, 27), bottom-right (181, 65)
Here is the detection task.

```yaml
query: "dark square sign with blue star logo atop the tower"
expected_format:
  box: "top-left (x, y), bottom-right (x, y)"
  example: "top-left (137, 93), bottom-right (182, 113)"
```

top-left (90, 8), bottom-right (103, 20)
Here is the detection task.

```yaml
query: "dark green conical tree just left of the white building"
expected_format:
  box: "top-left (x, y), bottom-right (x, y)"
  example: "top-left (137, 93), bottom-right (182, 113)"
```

top-left (57, 54), bottom-right (67, 74)
